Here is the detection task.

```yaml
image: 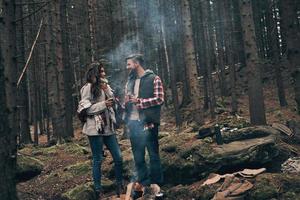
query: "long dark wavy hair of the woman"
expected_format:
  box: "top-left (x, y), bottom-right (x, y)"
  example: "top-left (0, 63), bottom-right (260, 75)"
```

top-left (86, 62), bottom-right (104, 99)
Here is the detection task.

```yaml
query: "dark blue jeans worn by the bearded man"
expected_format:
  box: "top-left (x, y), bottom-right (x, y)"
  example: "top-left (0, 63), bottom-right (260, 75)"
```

top-left (128, 120), bottom-right (163, 185)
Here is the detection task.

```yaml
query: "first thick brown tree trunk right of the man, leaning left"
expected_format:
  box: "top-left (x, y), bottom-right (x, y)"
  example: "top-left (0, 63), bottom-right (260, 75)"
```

top-left (182, 0), bottom-right (203, 124)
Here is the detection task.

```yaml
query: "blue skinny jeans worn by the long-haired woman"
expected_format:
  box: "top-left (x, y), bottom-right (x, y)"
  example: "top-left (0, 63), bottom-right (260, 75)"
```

top-left (88, 135), bottom-right (123, 190)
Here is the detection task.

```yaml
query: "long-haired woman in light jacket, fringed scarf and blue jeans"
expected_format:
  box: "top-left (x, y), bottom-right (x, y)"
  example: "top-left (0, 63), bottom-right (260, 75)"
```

top-left (77, 62), bottom-right (123, 197)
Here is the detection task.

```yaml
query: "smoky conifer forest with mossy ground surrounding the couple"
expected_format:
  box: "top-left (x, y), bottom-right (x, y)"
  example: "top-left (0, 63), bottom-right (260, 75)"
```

top-left (0, 0), bottom-right (300, 200)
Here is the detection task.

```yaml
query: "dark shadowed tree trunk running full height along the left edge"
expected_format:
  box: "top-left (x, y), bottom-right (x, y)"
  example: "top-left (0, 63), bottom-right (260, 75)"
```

top-left (0, 0), bottom-right (18, 200)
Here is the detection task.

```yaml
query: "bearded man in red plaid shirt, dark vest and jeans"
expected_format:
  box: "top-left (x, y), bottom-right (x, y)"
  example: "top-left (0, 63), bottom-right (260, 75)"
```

top-left (125, 54), bottom-right (164, 189)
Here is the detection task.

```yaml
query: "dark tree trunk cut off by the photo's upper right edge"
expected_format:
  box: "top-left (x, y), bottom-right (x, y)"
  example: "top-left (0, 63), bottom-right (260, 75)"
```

top-left (280, 0), bottom-right (300, 115)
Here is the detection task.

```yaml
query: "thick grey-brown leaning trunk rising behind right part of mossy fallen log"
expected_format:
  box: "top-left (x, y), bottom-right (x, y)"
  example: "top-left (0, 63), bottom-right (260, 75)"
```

top-left (239, 0), bottom-right (266, 125)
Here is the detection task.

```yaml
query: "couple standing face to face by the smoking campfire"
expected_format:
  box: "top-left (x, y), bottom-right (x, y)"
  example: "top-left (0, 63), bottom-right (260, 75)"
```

top-left (78, 54), bottom-right (164, 197)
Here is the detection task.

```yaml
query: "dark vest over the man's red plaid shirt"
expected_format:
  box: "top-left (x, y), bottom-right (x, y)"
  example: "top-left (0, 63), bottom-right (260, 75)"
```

top-left (138, 73), bottom-right (161, 124)
